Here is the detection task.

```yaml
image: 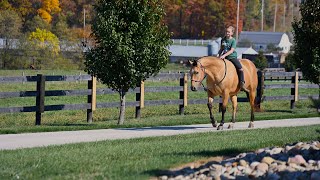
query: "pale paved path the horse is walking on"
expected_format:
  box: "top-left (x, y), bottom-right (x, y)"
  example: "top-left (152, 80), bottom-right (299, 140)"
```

top-left (0, 117), bottom-right (320, 150)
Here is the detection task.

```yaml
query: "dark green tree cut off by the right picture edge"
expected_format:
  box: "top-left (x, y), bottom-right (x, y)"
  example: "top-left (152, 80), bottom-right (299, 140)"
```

top-left (292, 0), bottom-right (320, 86)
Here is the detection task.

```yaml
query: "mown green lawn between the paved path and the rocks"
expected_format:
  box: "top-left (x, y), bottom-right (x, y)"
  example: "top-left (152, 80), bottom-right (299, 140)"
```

top-left (0, 125), bottom-right (320, 179)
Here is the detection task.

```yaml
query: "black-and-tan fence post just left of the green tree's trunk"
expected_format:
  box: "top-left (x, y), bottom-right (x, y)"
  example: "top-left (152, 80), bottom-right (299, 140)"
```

top-left (87, 76), bottom-right (97, 123)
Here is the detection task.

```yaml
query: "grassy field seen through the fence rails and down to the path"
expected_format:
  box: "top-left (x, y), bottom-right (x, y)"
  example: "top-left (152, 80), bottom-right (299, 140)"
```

top-left (0, 67), bottom-right (319, 134)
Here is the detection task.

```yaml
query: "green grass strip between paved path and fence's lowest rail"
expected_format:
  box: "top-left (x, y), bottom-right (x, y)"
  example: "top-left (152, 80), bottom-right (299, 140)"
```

top-left (0, 94), bottom-right (319, 134)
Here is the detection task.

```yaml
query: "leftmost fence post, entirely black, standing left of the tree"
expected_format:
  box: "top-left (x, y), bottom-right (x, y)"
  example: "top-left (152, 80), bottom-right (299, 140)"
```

top-left (36, 74), bottom-right (46, 125)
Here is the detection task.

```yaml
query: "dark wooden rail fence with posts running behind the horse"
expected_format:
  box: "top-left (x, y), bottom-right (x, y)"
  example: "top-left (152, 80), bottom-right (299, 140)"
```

top-left (0, 71), bottom-right (319, 125)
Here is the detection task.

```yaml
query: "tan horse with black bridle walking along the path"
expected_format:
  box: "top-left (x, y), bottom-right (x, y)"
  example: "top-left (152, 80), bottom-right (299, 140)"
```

top-left (189, 56), bottom-right (258, 130)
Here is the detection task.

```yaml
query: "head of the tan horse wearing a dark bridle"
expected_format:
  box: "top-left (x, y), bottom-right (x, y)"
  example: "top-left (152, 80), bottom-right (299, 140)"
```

top-left (189, 61), bottom-right (206, 91)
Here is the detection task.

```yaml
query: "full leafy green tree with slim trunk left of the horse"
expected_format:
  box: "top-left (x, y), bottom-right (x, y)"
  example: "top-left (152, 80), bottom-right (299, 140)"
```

top-left (85, 0), bottom-right (170, 124)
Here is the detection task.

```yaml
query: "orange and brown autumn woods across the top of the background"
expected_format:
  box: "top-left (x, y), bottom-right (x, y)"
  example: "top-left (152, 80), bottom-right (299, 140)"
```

top-left (0, 0), bottom-right (300, 39)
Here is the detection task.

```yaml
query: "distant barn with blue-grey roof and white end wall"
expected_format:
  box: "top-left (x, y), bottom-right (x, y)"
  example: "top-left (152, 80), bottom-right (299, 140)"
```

top-left (238, 31), bottom-right (292, 53)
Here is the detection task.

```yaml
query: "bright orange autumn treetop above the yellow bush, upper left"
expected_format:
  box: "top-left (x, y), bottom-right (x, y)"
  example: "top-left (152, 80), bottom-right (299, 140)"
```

top-left (38, 0), bottom-right (61, 23)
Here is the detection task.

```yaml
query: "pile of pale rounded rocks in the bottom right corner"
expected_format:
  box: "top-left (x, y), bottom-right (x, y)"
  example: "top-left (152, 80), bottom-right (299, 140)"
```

top-left (158, 141), bottom-right (320, 180)
